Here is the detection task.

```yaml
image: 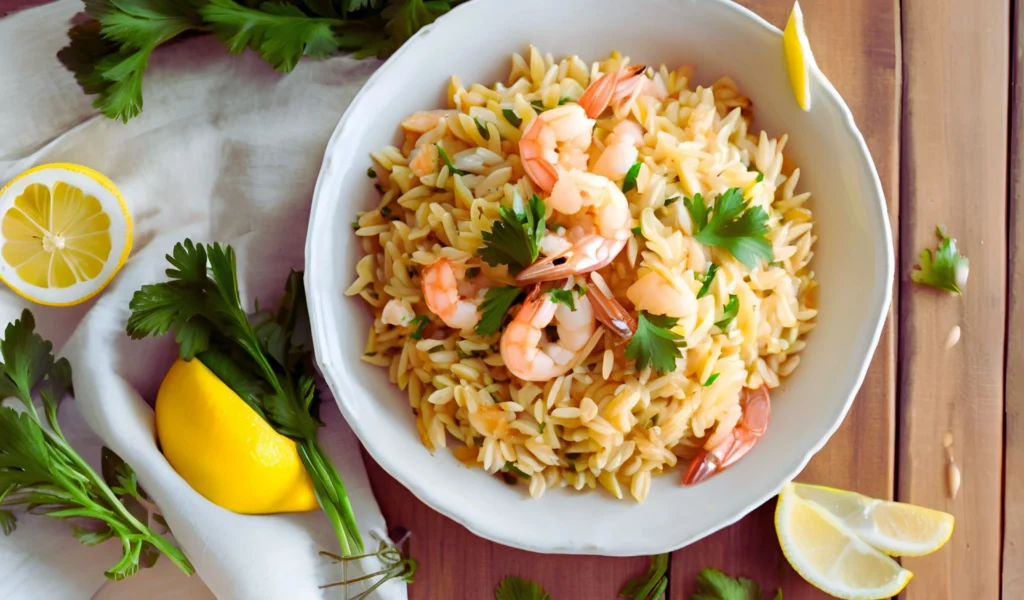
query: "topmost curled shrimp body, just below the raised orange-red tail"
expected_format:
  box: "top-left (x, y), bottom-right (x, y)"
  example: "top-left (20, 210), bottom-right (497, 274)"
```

top-left (519, 104), bottom-right (594, 192)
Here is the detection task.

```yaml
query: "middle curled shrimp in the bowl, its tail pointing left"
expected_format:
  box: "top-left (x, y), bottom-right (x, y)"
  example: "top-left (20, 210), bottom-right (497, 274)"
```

top-left (516, 171), bottom-right (632, 284)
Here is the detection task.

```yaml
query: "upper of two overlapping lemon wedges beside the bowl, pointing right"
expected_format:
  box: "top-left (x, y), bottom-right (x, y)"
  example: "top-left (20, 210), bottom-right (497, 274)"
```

top-left (793, 483), bottom-right (953, 556)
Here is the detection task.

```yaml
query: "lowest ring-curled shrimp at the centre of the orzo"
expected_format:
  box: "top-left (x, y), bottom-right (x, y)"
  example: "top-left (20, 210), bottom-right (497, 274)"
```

top-left (499, 277), bottom-right (597, 381)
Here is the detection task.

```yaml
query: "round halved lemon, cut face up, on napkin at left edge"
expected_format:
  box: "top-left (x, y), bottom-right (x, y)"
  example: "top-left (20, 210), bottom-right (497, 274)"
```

top-left (0, 163), bottom-right (132, 306)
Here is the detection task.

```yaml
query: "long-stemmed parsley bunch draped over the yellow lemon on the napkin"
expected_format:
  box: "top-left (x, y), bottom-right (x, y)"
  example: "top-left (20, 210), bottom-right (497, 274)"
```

top-left (127, 240), bottom-right (362, 555)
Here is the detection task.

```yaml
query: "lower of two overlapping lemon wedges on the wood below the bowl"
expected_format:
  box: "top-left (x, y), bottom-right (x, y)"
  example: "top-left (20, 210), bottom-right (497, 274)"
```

top-left (775, 483), bottom-right (913, 600)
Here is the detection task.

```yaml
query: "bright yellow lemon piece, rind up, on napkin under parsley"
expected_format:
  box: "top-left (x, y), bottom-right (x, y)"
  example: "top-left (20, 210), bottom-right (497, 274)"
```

top-left (156, 358), bottom-right (318, 514)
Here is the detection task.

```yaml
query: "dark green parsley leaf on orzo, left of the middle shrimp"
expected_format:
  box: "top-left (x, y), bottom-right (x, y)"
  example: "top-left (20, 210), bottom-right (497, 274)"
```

top-left (478, 194), bottom-right (546, 274)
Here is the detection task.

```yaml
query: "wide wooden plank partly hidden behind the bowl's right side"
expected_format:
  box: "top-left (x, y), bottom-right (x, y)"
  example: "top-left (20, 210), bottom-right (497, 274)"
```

top-left (670, 0), bottom-right (900, 600)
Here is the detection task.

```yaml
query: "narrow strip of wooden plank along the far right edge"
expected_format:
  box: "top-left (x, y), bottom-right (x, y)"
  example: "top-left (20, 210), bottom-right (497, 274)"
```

top-left (1002, 2), bottom-right (1024, 599)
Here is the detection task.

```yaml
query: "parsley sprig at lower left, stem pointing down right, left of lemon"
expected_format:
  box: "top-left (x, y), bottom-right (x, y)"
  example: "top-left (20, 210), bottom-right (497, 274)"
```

top-left (0, 310), bottom-right (195, 581)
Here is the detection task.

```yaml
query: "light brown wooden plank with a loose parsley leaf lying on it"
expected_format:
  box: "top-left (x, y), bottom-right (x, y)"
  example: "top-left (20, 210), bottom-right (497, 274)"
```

top-left (897, 0), bottom-right (1007, 600)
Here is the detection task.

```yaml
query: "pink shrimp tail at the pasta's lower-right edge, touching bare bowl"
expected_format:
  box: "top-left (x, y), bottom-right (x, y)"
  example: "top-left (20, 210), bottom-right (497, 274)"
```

top-left (683, 385), bottom-right (771, 485)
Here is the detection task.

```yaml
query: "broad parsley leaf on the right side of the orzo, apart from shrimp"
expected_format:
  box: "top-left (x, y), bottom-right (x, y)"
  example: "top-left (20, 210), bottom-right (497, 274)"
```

top-left (683, 187), bottom-right (774, 267)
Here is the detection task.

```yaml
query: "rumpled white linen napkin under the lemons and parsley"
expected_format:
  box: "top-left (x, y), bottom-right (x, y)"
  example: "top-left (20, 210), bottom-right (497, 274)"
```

top-left (0, 0), bottom-right (407, 600)
